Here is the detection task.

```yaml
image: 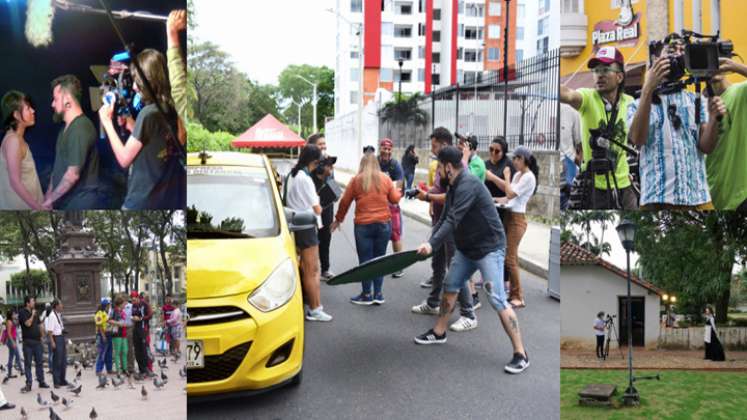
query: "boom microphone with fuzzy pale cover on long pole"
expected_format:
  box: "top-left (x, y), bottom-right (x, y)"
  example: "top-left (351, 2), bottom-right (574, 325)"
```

top-left (26, 0), bottom-right (168, 47)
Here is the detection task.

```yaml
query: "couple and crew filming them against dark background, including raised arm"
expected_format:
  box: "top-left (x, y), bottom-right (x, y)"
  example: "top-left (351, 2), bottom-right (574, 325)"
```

top-left (0, 10), bottom-right (187, 210)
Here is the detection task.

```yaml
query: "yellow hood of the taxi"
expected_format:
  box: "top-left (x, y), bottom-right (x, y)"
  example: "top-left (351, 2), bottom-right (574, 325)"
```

top-left (187, 236), bottom-right (289, 300)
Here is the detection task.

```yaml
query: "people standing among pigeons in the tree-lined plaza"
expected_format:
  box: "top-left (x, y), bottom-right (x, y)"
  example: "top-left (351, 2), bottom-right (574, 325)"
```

top-left (0, 291), bottom-right (184, 409)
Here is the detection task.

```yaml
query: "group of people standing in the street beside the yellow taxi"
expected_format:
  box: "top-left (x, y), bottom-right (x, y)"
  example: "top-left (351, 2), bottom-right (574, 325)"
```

top-left (283, 127), bottom-right (539, 373)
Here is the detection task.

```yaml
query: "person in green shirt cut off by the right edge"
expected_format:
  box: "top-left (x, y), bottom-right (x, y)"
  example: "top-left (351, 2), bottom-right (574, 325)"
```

top-left (706, 58), bottom-right (747, 212)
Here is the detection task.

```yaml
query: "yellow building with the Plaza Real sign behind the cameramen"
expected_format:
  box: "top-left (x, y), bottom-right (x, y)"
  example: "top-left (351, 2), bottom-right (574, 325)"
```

top-left (560, 0), bottom-right (747, 91)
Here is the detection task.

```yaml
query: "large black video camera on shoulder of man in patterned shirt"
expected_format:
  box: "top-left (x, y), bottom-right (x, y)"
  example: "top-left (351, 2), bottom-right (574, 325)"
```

top-left (648, 29), bottom-right (734, 93)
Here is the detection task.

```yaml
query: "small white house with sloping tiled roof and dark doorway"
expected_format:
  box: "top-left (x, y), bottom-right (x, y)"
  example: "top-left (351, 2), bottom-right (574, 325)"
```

top-left (560, 242), bottom-right (663, 349)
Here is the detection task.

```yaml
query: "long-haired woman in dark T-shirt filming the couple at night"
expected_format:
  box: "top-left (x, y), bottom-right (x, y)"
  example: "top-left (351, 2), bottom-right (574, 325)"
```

top-left (99, 49), bottom-right (187, 210)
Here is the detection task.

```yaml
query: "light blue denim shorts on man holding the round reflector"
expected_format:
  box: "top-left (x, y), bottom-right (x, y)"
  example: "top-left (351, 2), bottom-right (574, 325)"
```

top-left (444, 248), bottom-right (511, 312)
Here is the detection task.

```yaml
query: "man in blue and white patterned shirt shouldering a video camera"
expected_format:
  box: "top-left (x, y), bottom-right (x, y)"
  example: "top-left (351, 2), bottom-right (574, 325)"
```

top-left (627, 33), bottom-right (726, 210)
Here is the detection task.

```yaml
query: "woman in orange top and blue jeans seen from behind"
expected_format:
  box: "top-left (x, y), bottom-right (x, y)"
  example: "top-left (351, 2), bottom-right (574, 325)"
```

top-left (332, 154), bottom-right (402, 305)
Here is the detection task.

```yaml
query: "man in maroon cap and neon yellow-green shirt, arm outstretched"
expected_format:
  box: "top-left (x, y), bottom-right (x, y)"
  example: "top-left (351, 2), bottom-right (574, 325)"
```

top-left (560, 47), bottom-right (638, 210)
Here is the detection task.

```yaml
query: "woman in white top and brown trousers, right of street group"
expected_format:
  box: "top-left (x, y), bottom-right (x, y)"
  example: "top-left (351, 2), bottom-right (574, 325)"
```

top-left (495, 146), bottom-right (539, 308)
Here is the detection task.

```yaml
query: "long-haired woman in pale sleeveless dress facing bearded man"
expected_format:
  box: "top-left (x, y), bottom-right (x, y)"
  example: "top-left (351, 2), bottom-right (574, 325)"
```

top-left (0, 90), bottom-right (44, 210)
